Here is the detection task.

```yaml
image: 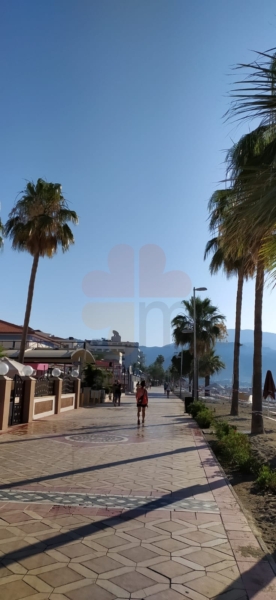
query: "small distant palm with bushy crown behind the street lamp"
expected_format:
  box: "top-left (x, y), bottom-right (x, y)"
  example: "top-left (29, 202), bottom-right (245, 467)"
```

top-left (172, 296), bottom-right (225, 396)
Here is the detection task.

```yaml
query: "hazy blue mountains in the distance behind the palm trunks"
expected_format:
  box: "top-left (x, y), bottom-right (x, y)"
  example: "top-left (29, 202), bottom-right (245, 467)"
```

top-left (140, 329), bottom-right (276, 385)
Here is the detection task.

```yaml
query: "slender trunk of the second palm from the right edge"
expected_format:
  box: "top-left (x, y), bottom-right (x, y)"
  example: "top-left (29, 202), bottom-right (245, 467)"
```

top-left (230, 267), bottom-right (244, 417)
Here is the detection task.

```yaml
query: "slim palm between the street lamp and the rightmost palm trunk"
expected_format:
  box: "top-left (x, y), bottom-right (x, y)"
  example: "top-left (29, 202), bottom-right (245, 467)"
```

top-left (204, 188), bottom-right (255, 416)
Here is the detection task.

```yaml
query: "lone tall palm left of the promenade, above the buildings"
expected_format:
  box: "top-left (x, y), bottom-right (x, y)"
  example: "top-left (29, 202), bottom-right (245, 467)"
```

top-left (5, 179), bottom-right (78, 362)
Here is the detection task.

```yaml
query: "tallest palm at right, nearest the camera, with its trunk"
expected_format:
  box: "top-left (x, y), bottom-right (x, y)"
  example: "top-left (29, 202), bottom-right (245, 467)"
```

top-left (226, 125), bottom-right (276, 433)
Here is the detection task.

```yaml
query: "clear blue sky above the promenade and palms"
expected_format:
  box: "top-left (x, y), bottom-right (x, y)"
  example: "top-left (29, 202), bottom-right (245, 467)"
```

top-left (0, 0), bottom-right (276, 345)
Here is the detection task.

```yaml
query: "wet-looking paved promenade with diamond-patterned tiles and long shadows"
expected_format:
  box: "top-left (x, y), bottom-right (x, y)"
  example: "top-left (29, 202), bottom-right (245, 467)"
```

top-left (0, 388), bottom-right (276, 600)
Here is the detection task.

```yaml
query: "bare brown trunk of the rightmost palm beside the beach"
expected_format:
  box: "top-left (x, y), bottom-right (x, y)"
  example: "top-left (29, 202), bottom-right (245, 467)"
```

top-left (251, 258), bottom-right (264, 433)
